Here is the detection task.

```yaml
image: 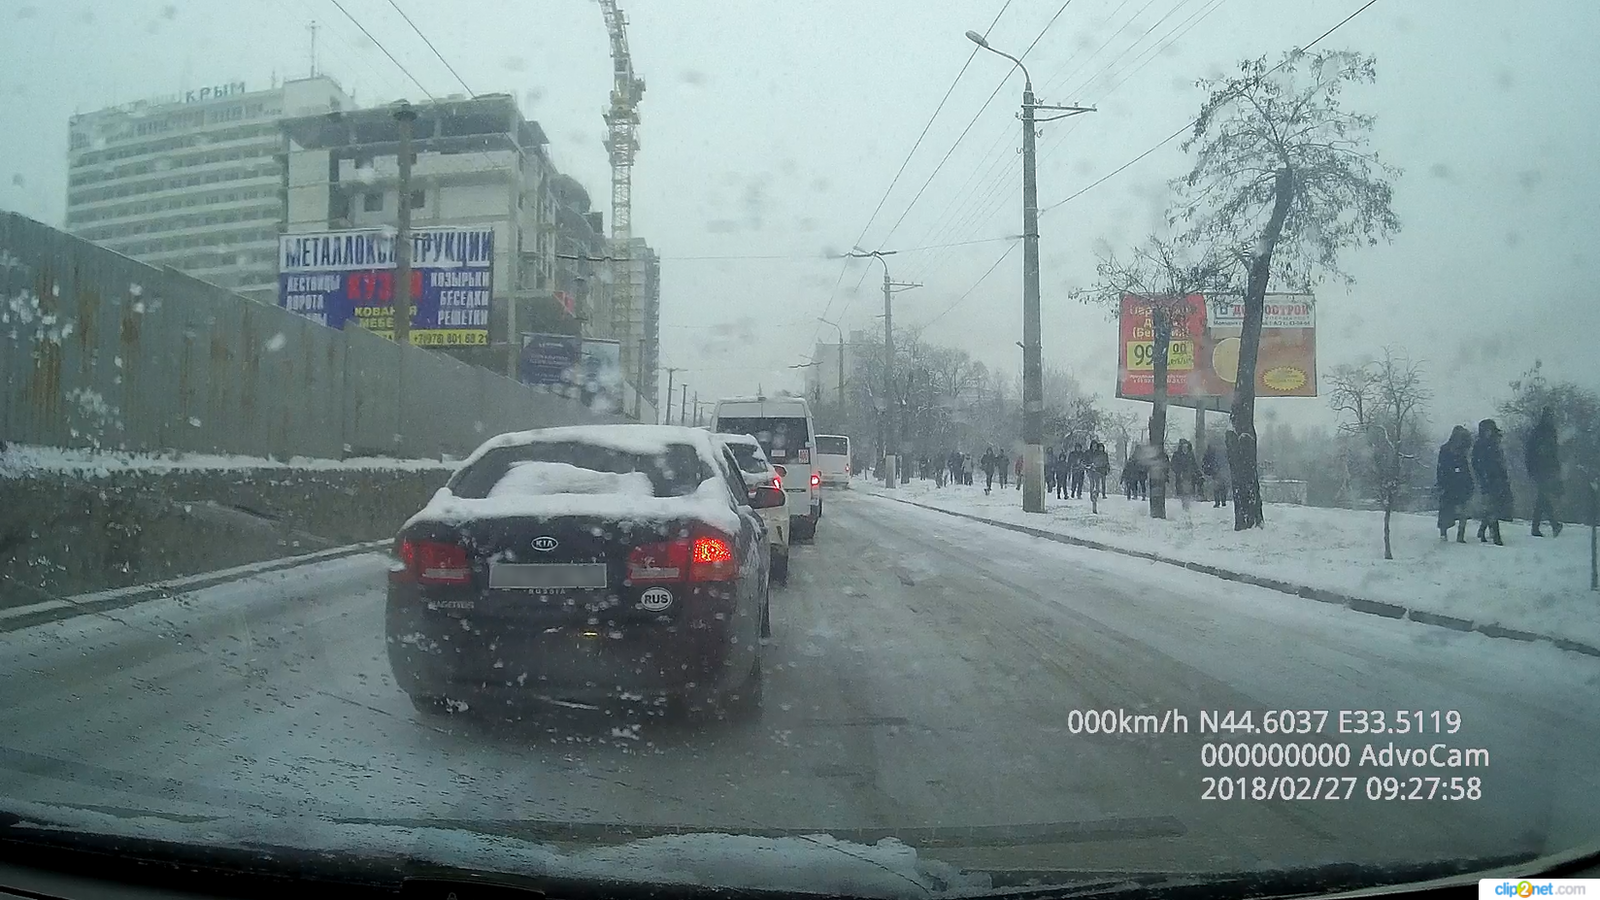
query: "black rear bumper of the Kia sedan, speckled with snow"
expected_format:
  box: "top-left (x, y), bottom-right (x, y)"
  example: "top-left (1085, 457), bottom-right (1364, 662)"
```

top-left (386, 583), bottom-right (749, 701)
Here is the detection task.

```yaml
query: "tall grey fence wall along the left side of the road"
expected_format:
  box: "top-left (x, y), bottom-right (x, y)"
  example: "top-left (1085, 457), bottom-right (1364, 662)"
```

top-left (0, 213), bottom-right (624, 458)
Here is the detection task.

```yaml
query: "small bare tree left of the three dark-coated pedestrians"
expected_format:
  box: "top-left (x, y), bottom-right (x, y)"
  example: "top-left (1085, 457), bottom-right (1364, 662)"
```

top-left (1328, 348), bottom-right (1432, 559)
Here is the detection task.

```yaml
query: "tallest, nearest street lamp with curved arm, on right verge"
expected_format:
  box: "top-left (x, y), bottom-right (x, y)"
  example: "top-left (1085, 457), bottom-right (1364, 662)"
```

top-left (966, 30), bottom-right (1093, 512)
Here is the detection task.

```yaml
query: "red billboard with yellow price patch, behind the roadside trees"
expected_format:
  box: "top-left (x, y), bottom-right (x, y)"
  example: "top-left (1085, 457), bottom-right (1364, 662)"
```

top-left (1117, 293), bottom-right (1317, 408)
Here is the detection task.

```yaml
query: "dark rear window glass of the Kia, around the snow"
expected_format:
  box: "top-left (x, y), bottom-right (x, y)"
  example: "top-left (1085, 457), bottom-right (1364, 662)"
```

top-left (450, 442), bottom-right (710, 500)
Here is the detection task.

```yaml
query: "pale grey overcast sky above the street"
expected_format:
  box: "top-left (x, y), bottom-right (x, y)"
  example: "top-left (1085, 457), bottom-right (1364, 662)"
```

top-left (0, 0), bottom-right (1600, 435)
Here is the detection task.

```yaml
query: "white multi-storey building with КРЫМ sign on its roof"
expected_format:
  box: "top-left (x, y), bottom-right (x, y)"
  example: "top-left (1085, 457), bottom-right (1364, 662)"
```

top-left (66, 75), bottom-right (354, 299)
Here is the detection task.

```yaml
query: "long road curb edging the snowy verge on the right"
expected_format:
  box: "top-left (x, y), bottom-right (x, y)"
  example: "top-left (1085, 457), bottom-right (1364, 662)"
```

top-left (866, 492), bottom-right (1600, 658)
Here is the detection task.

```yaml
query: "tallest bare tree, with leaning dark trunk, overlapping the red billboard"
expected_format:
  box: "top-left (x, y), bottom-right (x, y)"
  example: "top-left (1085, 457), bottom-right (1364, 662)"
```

top-left (1173, 50), bottom-right (1400, 528)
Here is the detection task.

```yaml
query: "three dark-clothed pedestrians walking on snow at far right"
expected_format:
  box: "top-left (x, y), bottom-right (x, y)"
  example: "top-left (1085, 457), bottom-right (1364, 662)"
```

top-left (1435, 407), bottom-right (1562, 546)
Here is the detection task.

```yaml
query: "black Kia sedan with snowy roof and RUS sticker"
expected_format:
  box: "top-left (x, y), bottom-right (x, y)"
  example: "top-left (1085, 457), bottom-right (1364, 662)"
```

top-left (386, 424), bottom-right (782, 714)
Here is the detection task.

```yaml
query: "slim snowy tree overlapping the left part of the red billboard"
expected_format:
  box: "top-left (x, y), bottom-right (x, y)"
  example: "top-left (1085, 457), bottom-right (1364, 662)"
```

top-left (1072, 234), bottom-right (1237, 519)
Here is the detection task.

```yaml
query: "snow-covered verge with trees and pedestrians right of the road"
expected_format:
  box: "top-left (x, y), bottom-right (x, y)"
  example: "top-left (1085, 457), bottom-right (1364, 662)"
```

top-left (854, 474), bottom-right (1600, 645)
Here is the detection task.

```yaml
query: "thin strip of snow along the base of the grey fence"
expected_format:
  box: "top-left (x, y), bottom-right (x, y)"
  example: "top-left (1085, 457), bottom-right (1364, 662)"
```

top-left (0, 444), bottom-right (461, 477)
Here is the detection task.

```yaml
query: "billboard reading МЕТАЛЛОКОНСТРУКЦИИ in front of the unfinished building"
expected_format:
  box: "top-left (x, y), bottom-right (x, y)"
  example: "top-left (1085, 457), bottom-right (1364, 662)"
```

top-left (278, 227), bottom-right (494, 348)
